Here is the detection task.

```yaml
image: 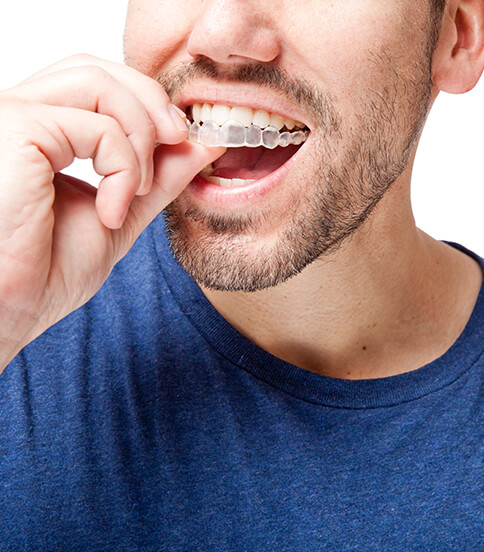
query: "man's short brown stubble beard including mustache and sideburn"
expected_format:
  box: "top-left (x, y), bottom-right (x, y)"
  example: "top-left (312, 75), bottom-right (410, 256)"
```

top-left (161, 33), bottom-right (435, 292)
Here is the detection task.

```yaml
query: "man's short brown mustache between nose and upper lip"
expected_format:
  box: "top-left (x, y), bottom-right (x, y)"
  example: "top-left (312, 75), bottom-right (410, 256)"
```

top-left (157, 58), bottom-right (342, 134)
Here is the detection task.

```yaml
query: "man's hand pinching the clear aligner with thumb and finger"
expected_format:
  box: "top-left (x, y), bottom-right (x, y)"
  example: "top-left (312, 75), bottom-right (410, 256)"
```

top-left (0, 55), bottom-right (224, 370)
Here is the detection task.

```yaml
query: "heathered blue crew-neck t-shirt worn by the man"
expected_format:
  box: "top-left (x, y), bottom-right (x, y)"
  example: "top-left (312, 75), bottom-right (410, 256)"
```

top-left (0, 215), bottom-right (484, 552)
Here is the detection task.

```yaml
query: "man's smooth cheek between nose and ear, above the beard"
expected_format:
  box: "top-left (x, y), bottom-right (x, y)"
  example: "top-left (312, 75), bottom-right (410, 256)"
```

top-left (286, 0), bottom-right (425, 106)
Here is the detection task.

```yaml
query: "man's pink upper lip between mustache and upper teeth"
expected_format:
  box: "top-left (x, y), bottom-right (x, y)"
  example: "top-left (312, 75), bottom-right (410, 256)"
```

top-left (173, 81), bottom-right (315, 130)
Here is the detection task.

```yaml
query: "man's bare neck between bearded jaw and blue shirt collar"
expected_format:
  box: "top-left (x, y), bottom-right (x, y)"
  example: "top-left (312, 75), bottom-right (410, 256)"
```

top-left (202, 167), bottom-right (482, 379)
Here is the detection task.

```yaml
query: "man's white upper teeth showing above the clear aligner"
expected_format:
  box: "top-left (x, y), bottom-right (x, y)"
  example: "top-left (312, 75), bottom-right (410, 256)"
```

top-left (191, 103), bottom-right (305, 130)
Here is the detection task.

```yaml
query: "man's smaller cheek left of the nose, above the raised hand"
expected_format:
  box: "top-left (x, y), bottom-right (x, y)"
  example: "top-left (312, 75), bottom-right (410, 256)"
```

top-left (124, 0), bottom-right (194, 75)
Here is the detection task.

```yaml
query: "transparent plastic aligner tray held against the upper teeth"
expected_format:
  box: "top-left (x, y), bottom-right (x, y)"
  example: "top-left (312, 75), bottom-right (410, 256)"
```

top-left (187, 121), bottom-right (309, 149)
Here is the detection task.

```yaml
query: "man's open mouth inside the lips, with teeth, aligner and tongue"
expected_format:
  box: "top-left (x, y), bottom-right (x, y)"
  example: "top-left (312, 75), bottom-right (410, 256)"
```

top-left (187, 103), bottom-right (310, 188)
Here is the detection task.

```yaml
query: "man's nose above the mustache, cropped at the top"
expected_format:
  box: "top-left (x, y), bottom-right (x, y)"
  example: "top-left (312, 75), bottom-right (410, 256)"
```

top-left (188, 0), bottom-right (280, 64)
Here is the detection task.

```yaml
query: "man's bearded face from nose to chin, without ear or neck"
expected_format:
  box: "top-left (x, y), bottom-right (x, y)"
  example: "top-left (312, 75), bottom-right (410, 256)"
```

top-left (125, 0), bottom-right (438, 291)
